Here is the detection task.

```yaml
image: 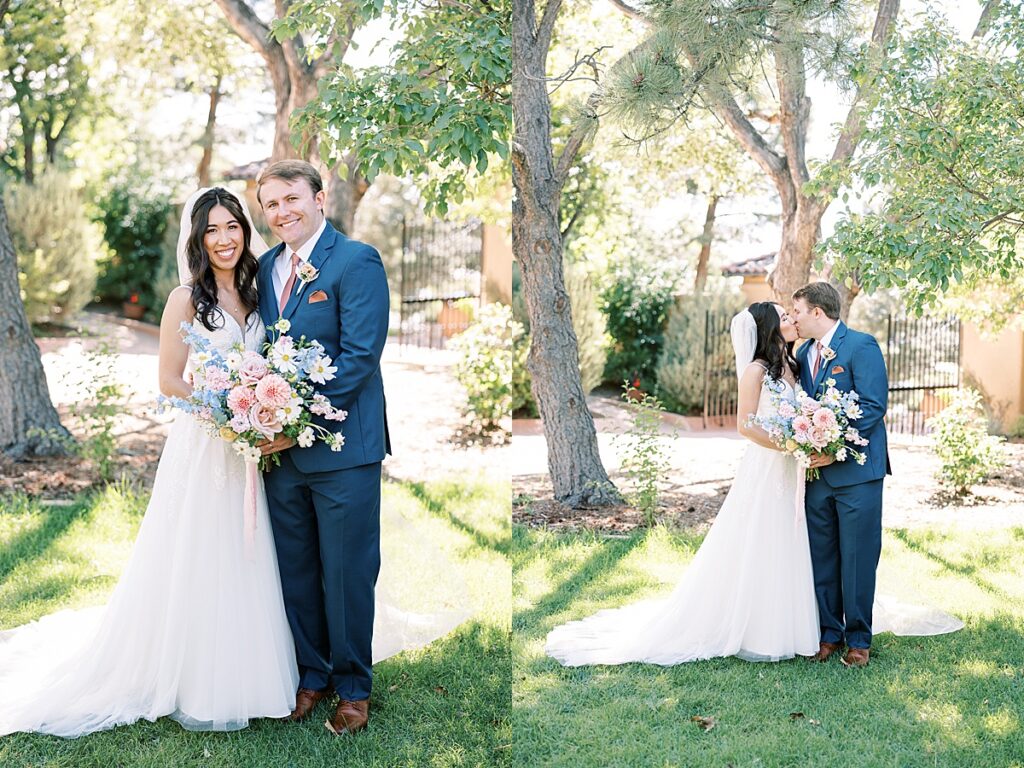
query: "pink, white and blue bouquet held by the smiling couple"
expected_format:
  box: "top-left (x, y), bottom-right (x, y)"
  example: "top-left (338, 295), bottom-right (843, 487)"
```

top-left (160, 318), bottom-right (348, 469)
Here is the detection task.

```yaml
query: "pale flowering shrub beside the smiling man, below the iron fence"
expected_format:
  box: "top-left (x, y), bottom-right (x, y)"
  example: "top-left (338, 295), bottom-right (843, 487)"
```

top-left (452, 303), bottom-right (522, 436)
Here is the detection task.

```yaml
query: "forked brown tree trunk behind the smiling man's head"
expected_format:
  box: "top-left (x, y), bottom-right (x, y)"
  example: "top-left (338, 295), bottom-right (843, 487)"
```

top-left (216, 0), bottom-right (370, 228)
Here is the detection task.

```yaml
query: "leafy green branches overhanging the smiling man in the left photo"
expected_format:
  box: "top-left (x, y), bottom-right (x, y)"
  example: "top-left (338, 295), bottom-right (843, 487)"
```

top-left (274, 0), bottom-right (512, 219)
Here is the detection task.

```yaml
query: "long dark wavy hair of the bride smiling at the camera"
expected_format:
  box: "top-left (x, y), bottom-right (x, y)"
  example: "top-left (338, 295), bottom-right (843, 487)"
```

top-left (186, 186), bottom-right (259, 331)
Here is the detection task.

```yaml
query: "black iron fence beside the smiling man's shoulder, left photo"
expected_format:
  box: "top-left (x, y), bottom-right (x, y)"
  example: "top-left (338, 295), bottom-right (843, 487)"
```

top-left (399, 220), bottom-right (483, 348)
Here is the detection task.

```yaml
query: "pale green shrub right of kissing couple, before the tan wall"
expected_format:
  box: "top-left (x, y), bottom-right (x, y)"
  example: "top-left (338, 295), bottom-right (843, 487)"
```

top-left (928, 389), bottom-right (1006, 496)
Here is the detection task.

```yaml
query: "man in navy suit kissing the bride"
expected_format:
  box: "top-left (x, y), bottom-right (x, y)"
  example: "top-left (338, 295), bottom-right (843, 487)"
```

top-left (793, 283), bottom-right (892, 667)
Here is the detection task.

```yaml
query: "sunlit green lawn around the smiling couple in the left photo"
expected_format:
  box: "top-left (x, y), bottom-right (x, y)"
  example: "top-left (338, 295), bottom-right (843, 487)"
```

top-left (0, 478), bottom-right (512, 768)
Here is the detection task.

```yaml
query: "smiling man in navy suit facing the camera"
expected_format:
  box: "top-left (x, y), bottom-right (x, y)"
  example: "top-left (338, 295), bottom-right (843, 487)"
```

top-left (256, 160), bottom-right (391, 734)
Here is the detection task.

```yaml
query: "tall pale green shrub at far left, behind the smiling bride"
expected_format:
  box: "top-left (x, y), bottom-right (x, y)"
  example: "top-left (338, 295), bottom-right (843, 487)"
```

top-left (4, 170), bottom-right (102, 323)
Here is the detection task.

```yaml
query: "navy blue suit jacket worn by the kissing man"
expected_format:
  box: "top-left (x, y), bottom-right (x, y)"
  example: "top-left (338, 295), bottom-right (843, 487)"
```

top-left (797, 322), bottom-right (892, 487)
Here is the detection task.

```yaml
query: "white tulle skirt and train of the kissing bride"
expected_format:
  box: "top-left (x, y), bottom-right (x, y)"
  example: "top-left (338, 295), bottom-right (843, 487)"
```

top-left (546, 445), bottom-right (818, 667)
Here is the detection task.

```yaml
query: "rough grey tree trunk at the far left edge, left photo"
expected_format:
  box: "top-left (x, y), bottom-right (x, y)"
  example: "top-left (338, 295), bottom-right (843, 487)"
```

top-left (0, 196), bottom-right (71, 459)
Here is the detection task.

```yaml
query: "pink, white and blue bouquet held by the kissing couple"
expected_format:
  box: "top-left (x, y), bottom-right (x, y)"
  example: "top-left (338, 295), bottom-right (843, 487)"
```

top-left (749, 379), bottom-right (867, 480)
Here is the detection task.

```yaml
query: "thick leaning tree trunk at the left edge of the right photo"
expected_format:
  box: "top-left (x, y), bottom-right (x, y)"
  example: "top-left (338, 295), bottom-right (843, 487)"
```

top-left (512, 0), bottom-right (620, 507)
